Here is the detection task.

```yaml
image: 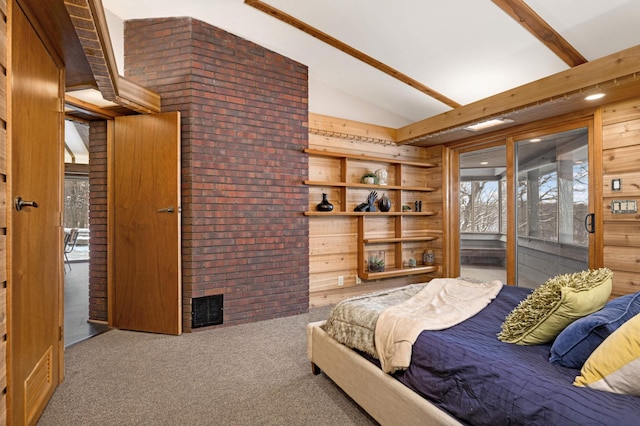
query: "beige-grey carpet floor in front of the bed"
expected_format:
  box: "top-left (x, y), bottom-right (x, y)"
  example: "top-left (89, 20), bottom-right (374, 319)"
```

top-left (38, 308), bottom-right (376, 426)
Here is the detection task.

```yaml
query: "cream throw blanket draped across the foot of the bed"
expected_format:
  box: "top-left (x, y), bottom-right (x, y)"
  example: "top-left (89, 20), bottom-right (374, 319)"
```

top-left (375, 278), bottom-right (502, 373)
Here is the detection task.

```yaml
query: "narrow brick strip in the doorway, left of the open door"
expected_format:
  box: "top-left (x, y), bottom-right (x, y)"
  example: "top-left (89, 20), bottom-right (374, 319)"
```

top-left (89, 121), bottom-right (108, 321)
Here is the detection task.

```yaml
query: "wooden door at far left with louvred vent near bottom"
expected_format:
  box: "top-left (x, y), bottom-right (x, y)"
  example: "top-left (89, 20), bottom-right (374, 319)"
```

top-left (7, 4), bottom-right (64, 425)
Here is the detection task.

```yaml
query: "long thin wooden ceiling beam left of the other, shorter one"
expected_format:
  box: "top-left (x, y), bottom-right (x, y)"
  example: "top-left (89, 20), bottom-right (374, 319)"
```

top-left (245, 0), bottom-right (461, 108)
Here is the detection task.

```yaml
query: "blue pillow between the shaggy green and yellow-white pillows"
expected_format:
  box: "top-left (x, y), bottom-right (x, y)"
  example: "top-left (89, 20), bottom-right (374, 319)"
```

top-left (549, 292), bottom-right (640, 369)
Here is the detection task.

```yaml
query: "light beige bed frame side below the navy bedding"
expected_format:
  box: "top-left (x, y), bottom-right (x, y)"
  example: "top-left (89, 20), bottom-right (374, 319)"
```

top-left (307, 321), bottom-right (461, 425)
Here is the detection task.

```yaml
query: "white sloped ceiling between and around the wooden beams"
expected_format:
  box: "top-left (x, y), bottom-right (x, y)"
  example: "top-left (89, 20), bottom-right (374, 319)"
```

top-left (102, 0), bottom-right (640, 128)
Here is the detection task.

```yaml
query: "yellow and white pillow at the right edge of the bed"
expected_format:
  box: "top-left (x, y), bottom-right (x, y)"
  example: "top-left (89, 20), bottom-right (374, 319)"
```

top-left (573, 315), bottom-right (640, 396)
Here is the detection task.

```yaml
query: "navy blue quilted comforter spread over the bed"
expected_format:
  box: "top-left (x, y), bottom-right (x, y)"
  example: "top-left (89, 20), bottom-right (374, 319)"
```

top-left (395, 286), bottom-right (640, 426)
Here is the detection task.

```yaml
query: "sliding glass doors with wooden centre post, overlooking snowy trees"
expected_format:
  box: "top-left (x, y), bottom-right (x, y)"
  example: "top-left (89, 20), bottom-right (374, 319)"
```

top-left (457, 126), bottom-right (593, 288)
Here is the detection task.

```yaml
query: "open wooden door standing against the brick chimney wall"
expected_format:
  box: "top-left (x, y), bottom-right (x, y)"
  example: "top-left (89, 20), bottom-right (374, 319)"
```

top-left (109, 113), bottom-right (182, 334)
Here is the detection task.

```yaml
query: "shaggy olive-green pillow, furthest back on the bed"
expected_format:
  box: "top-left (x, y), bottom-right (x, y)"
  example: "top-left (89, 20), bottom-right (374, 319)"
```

top-left (498, 268), bottom-right (613, 345)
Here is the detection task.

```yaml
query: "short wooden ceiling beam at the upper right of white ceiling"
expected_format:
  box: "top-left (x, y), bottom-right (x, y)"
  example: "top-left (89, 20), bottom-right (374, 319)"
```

top-left (491, 0), bottom-right (587, 67)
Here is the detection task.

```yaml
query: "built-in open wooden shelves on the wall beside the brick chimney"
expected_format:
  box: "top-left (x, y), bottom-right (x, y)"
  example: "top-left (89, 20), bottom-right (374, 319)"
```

top-left (304, 149), bottom-right (439, 280)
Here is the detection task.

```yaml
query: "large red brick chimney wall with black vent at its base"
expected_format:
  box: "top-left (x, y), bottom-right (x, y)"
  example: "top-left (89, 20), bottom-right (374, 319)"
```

top-left (122, 18), bottom-right (309, 331)
